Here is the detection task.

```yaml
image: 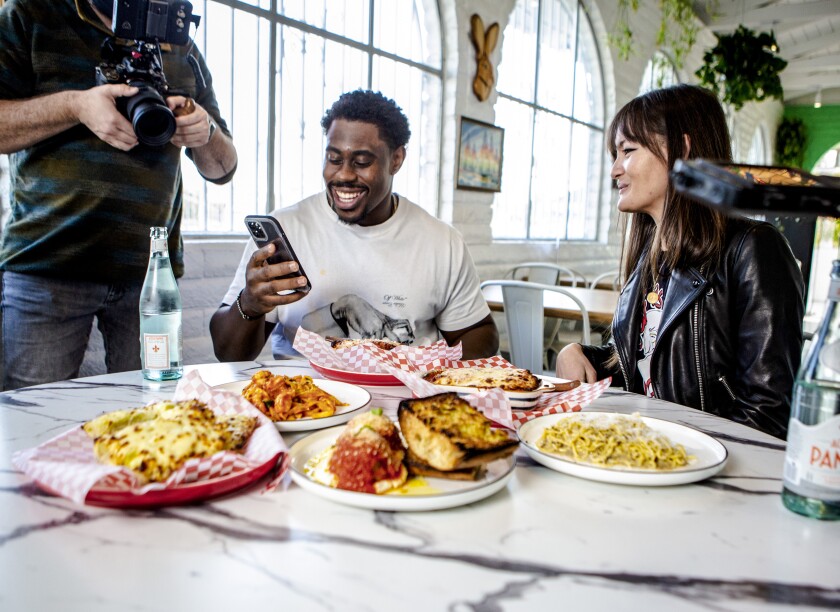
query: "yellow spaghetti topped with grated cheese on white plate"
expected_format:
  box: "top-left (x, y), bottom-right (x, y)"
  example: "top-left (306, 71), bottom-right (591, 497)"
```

top-left (537, 413), bottom-right (691, 470)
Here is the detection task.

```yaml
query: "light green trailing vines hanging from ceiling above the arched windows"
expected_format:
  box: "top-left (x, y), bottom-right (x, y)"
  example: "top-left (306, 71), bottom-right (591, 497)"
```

top-left (607, 0), bottom-right (700, 68)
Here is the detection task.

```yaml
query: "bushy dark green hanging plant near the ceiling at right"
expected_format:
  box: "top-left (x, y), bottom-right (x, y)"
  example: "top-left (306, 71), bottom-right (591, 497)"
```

top-left (694, 25), bottom-right (787, 110)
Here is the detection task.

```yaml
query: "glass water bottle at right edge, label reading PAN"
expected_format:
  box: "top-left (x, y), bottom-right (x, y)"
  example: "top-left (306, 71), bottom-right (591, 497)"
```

top-left (782, 260), bottom-right (840, 520)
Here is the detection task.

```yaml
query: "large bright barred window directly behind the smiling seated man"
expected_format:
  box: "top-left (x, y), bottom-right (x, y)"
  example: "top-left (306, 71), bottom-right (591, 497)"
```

top-left (183, 0), bottom-right (442, 234)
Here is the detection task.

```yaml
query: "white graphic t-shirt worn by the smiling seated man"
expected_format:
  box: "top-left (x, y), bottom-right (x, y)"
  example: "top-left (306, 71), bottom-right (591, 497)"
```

top-left (223, 191), bottom-right (490, 358)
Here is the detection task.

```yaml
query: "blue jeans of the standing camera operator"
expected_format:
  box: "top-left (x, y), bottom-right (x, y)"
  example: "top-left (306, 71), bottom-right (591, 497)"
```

top-left (0, 272), bottom-right (143, 390)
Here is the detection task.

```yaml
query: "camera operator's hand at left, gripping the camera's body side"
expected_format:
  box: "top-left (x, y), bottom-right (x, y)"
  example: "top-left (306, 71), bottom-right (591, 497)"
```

top-left (75, 84), bottom-right (138, 151)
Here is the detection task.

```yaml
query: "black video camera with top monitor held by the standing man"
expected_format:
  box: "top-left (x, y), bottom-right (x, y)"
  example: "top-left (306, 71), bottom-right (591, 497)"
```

top-left (96, 0), bottom-right (200, 146)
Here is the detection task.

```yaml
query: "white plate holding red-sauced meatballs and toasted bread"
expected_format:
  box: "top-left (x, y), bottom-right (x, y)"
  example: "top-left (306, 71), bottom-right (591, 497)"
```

top-left (289, 427), bottom-right (516, 511)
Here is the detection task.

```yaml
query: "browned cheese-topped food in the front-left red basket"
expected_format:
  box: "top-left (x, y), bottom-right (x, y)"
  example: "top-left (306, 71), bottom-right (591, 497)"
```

top-left (82, 400), bottom-right (257, 483)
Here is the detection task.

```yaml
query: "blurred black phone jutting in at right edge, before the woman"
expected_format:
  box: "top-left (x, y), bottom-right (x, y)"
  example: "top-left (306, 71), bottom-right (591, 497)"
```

top-left (671, 160), bottom-right (840, 217)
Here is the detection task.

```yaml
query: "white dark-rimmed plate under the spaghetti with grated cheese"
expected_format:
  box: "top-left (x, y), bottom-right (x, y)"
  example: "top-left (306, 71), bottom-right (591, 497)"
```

top-left (517, 411), bottom-right (728, 487)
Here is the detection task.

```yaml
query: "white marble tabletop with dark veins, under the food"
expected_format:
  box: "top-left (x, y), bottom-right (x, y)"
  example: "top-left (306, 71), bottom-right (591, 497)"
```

top-left (0, 362), bottom-right (840, 612)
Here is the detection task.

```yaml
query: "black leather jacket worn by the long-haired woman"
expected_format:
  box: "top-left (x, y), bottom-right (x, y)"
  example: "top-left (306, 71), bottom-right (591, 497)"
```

top-left (583, 219), bottom-right (805, 438)
